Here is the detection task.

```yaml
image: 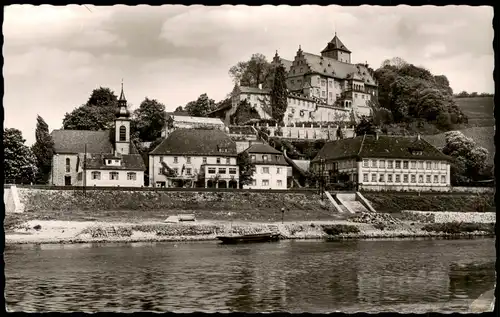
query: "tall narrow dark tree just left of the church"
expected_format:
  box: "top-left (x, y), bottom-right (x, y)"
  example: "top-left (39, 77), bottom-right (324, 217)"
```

top-left (32, 116), bottom-right (54, 184)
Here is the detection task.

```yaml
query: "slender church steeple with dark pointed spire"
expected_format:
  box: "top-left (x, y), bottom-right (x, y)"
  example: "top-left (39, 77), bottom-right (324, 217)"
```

top-left (115, 81), bottom-right (130, 155)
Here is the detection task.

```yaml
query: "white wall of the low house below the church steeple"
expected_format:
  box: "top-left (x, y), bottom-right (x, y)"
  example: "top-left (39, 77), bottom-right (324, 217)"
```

top-left (76, 170), bottom-right (144, 187)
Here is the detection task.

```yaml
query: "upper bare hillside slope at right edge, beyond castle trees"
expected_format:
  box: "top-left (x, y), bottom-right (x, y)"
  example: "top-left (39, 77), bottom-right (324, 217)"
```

top-left (455, 97), bottom-right (495, 127)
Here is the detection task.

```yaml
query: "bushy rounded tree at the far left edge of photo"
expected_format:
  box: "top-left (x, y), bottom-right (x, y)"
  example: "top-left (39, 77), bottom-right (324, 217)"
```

top-left (3, 129), bottom-right (37, 183)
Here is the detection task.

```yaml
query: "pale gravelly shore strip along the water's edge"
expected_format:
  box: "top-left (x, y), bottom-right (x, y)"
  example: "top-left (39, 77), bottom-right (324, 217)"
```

top-left (5, 220), bottom-right (494, 245)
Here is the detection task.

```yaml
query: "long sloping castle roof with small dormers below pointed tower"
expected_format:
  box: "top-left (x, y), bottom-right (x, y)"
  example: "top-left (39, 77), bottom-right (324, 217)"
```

top-left (302, 52), bottom-right (376, 85)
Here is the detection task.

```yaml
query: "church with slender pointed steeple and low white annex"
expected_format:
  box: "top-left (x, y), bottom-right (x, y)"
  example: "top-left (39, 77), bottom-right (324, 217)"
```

top-left (49, 84), bottom-right (146, 187)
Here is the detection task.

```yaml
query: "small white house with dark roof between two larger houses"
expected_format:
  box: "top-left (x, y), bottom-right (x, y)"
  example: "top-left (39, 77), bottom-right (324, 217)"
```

top-left (243, 144), bottom-right (288, 189)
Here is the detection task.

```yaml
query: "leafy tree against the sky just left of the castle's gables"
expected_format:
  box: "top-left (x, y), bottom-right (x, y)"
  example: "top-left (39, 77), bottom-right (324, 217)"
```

top-left (229, 53), bottom-right (272, 87)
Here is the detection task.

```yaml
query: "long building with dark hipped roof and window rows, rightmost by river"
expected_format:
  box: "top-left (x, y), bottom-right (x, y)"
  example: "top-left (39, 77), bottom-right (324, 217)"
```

top-left (311, 134), bottom-right (451, 191)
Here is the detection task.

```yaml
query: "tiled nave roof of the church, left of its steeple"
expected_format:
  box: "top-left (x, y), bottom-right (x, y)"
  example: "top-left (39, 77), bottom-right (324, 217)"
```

top-left (51, 130), bottom-right (113, 154)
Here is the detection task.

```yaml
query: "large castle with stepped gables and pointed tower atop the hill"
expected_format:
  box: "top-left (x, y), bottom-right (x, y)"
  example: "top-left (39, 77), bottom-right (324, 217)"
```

top-left (210, 34), bottom-right (378, 125)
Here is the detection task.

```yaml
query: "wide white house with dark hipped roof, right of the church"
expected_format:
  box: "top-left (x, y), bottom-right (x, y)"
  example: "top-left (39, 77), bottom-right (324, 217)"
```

top-left (149, 129), bottom-right (239, 188)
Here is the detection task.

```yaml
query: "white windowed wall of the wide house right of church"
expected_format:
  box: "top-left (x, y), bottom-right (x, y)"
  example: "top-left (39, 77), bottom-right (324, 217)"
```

top-left (149, 153), bottom-right (236, 186)
